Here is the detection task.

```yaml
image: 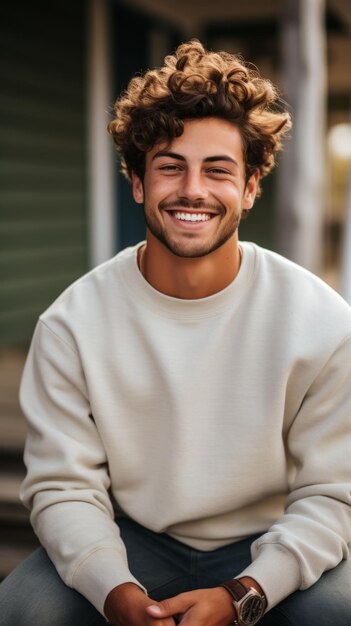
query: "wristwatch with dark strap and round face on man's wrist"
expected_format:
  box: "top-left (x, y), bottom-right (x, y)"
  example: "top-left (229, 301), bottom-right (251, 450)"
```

top-left (221, 578), bottom-right (267, 626)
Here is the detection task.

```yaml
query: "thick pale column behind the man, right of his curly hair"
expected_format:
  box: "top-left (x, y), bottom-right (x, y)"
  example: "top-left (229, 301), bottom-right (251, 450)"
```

top-left (279, 0), bottom-right (326, 273)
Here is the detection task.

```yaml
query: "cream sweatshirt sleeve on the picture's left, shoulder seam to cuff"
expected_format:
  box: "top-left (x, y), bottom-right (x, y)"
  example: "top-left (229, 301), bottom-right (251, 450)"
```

top-left (20, 321), bottom-right (142, 614)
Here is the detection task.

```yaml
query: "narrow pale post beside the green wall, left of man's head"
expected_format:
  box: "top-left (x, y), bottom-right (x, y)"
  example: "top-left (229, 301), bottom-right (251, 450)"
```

top-left (88, 0), bottom-right (117, 267)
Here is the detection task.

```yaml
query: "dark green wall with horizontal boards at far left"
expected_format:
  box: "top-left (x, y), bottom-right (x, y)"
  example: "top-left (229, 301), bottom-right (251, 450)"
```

top-left (0, 0), bottom-right (87, 347)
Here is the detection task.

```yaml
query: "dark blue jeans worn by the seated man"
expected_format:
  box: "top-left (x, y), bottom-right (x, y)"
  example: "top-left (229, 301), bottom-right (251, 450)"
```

top-left (0, 519), bottom-right (351, 626)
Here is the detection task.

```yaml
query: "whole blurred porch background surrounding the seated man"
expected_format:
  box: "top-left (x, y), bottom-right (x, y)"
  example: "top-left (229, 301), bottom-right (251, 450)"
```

top-left (0, 0), bottom-right (351, 579)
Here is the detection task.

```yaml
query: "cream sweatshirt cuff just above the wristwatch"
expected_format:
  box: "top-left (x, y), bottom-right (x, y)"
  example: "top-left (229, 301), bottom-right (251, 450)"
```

top-left (236, 543), bottom-right (301, 610)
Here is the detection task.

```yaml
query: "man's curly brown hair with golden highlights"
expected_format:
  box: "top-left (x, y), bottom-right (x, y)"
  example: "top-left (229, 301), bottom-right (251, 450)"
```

top-left (108, 39), bottom-right (291, 196)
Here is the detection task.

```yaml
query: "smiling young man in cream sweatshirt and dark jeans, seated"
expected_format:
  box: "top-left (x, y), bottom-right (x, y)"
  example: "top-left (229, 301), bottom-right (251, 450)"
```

top-left (0, 41), bottom-right (351, 626)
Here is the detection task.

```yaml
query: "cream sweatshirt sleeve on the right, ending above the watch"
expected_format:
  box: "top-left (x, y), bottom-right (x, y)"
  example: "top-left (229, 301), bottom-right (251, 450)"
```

top-left (242, 337), bottom-right (351, 608)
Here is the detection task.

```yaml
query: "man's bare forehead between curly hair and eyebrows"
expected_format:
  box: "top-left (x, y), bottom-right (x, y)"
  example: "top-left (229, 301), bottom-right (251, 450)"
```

top-left (146, 117), bottom-right (243, 164)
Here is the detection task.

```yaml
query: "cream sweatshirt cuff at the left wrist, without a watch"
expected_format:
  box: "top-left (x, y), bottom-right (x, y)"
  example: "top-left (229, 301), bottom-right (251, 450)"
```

top-left (72, 548), bottom-right (147, 619)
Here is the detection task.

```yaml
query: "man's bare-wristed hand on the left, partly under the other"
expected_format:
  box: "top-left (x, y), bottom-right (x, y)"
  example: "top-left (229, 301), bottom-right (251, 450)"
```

top-left (104, 583), bottom-right (175, 626)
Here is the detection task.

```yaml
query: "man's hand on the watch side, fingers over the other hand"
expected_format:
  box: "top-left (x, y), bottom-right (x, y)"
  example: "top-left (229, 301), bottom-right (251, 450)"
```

top-left (146, 587), bottom-right (235, 626)
